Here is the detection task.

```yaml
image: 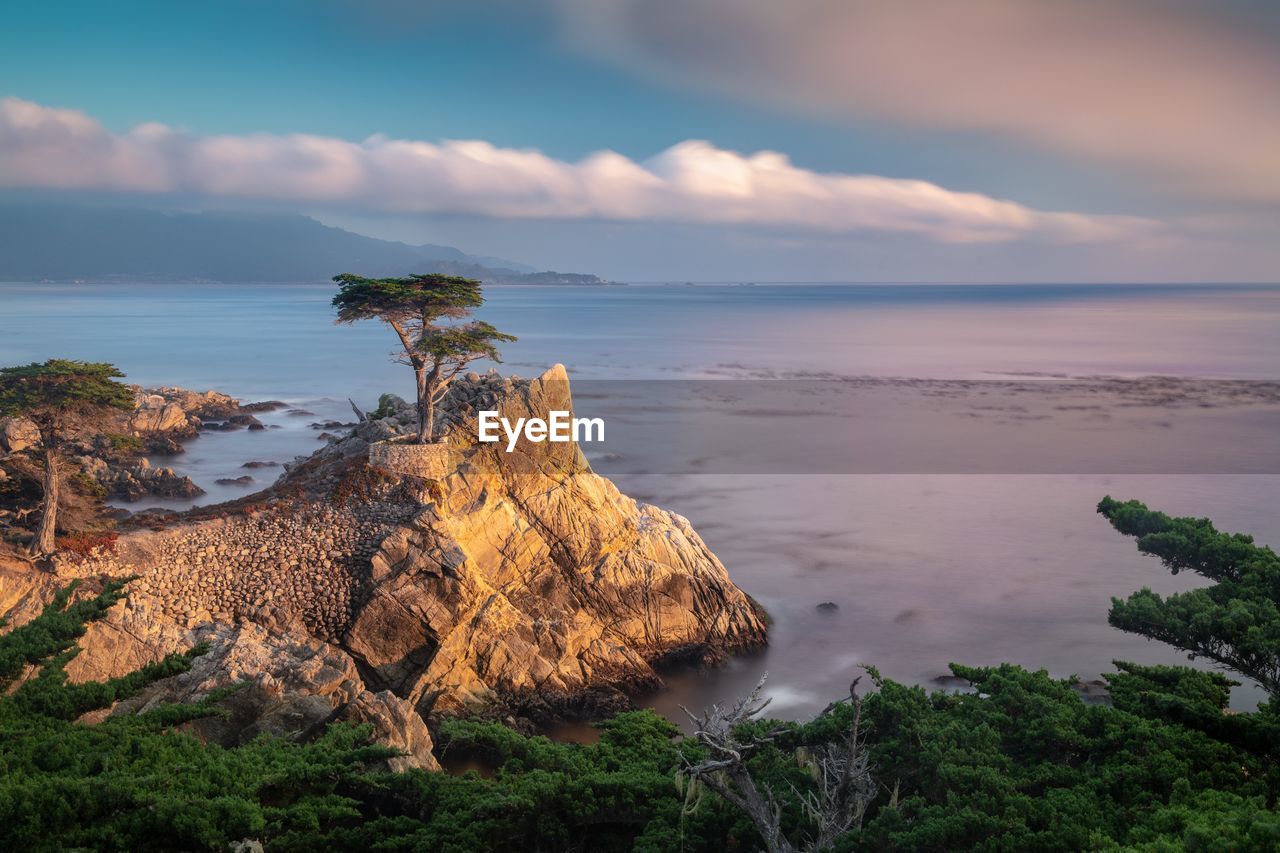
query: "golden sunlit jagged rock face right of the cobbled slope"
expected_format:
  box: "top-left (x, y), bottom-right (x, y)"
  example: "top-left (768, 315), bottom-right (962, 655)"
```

top-left (344, 366), bottom-right (764, 711)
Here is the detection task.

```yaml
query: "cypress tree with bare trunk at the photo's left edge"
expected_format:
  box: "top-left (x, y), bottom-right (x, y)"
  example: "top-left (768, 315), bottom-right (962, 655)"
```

top-left (0, 359), bottom-right (133, 557)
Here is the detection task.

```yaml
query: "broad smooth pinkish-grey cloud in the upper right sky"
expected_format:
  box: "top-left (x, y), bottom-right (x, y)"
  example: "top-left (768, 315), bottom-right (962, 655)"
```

top-left (552, 0), bottom-right (1280, 202)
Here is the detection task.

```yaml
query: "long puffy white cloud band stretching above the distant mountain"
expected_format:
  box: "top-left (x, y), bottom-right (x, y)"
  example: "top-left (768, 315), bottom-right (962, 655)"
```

top-left (0, 97), bottom-right (1158, 243)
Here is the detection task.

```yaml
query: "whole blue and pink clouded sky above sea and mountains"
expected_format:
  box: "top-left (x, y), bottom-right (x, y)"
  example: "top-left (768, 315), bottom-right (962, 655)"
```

top-left (0, 0), bottom-right (1280, 280)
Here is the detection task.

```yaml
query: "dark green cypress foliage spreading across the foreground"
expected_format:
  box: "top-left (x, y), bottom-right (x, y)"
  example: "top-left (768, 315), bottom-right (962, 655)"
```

top-left (0, 498), bottom-right (1280, 850)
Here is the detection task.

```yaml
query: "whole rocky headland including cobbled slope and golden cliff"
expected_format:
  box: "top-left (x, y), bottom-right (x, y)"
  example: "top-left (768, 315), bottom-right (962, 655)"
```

top-left (0, 366), bottom-right (765, 765)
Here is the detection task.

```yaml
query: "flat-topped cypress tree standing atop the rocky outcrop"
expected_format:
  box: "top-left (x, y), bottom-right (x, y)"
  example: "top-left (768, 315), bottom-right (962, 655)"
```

top-left (333, 273), bottom-right (516, 444)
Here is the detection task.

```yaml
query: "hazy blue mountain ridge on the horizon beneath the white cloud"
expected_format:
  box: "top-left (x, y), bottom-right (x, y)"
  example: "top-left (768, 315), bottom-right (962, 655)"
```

top-left (0, 202), bottom-right (603, 284)
